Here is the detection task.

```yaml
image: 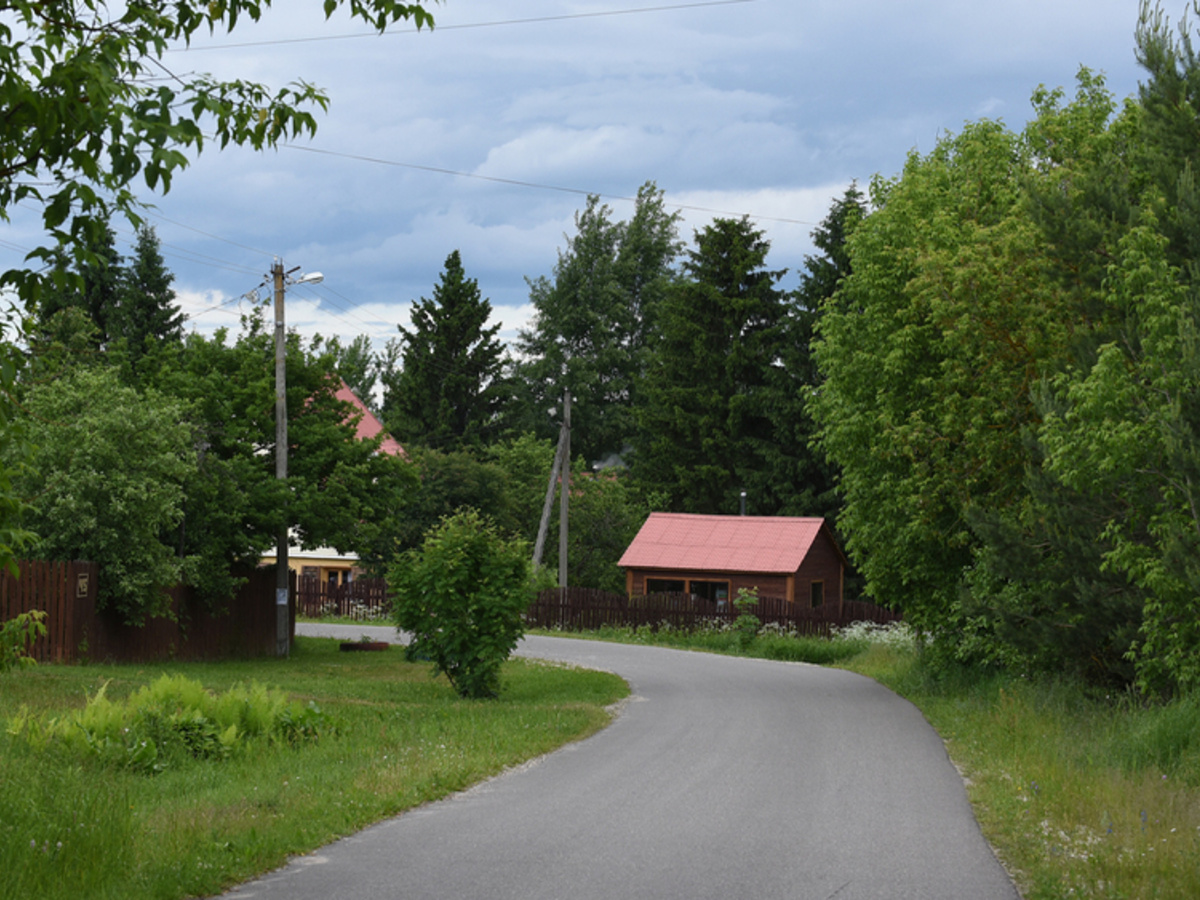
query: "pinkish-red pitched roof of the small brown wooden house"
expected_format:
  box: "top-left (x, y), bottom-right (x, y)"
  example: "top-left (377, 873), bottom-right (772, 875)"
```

top-left (618, 512), bottom-right (824, 575)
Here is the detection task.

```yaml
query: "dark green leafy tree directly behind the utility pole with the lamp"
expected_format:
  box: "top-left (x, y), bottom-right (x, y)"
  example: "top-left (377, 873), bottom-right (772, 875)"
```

top-left (139, 311), bottom-right (412, 601)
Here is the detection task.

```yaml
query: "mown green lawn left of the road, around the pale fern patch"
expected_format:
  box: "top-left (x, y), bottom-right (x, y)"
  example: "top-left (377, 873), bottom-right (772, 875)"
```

top-left (0, 637), bottom-right (628, 900)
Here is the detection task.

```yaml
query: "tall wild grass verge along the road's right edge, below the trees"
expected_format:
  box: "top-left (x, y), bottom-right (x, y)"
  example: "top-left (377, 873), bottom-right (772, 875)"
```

top-left (846, 647), bottom-right (1200, 900)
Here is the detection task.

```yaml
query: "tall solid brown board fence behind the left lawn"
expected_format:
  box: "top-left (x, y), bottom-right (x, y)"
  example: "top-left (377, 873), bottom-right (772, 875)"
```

top-left (0, 560), bottom-right (295, 662)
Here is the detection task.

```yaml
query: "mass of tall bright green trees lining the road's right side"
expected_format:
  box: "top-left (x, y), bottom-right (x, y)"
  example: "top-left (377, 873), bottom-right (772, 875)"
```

top-left (812, 2), bottom-right (1200, 694)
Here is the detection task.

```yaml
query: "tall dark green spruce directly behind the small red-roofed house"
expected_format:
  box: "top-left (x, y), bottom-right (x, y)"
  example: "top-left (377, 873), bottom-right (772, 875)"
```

top-left (634, 218), bottom-right (788, 514)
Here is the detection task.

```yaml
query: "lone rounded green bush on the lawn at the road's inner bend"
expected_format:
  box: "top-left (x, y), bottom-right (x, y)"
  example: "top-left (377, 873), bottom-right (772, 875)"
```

top-left (388, 509), bottom-right (534, 698)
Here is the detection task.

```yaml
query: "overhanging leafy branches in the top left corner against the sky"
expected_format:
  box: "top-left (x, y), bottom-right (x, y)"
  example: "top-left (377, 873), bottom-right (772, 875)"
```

top-left (0, 0), bottom-right (432, 301)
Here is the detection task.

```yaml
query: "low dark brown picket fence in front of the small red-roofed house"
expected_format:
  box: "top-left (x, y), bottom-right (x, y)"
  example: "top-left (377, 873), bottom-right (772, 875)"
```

top-left (526, 588), bottom-right (901, 636)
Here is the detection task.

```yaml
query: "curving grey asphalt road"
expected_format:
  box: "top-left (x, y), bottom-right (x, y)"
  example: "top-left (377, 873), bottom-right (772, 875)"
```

top-left (226, 625), bottom-right (1018, 900)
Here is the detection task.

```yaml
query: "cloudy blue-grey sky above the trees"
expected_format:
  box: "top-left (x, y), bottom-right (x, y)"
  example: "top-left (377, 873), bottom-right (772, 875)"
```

top-left (7, 0), bottom-right (1152, 355)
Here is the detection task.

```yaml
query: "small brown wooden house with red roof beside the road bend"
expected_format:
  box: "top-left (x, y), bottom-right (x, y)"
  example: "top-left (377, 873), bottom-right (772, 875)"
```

top-left (619, 512), bottom-right (846, 607)
